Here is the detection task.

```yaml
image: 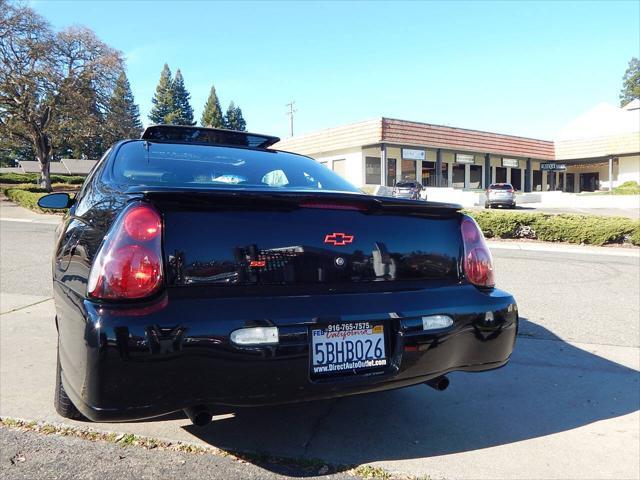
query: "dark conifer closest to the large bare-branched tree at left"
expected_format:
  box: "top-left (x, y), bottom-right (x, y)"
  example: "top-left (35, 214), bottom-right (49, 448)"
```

top-left (104, 71), bottom-right (142, 145)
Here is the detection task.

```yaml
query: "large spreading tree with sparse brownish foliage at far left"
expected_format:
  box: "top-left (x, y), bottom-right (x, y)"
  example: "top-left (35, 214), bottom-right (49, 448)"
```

top-left (0, 4), bottom-right (122, 190)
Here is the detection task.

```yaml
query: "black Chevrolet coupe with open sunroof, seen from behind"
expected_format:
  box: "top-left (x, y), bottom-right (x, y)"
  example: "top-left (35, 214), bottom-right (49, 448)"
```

top-left (40, 126), bottom-right (518, 424)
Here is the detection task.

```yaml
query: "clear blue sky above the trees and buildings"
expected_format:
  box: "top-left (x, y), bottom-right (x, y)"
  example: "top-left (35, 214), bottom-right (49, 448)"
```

top-left (30, 0), bottom-right (640, 138)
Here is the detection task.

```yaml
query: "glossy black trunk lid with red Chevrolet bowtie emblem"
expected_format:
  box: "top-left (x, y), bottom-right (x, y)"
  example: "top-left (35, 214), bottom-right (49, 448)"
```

top-left (136, 189), bottom-right (462, 293)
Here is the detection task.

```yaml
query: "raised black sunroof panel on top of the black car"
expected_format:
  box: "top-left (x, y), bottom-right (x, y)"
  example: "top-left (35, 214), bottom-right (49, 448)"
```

top-left (140, 125), bottom-right (280, 149)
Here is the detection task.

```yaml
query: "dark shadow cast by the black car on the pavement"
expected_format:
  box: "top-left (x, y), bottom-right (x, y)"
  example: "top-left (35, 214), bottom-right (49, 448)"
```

top-left (185, 318), bottom-right (640, 476)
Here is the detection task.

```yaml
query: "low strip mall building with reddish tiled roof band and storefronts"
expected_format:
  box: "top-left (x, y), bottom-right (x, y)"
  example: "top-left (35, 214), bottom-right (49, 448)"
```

top-left (275, 100), bottom-right (640, 192)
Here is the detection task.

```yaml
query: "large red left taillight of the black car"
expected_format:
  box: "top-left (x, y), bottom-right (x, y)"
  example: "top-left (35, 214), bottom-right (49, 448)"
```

top-left (88, 203), bottom-right (162, 300)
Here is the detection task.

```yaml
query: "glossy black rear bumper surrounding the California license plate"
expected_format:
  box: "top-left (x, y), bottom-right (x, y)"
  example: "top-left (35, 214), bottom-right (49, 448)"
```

top-left (56, 285), bottom-right (518, 421)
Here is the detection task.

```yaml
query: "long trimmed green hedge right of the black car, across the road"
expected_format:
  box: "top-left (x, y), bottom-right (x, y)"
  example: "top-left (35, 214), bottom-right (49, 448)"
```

top-left (466, 211), bottom-right (640, 246)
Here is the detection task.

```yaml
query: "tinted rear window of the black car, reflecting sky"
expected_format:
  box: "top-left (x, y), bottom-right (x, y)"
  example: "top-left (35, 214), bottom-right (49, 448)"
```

top-left (112, 141), bottom-right (359, 192)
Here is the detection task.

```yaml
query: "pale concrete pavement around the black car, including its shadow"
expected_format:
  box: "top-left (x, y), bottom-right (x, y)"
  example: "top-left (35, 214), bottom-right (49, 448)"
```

top-left (0, 206), bottom-right (640, 478)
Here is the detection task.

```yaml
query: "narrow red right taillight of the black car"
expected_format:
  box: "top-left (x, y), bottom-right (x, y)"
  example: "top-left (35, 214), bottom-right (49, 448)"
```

top-left (460, 215), bottom-right (495, 288)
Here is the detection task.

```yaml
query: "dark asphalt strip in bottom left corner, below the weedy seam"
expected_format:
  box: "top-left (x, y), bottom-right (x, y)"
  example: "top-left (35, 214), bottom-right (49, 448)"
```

top-left (0, 428), bottom-right (354, 480)
